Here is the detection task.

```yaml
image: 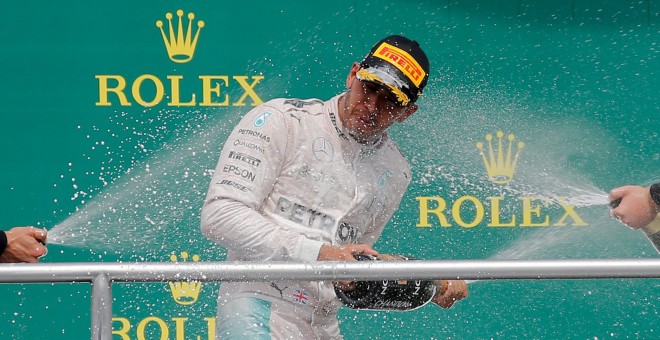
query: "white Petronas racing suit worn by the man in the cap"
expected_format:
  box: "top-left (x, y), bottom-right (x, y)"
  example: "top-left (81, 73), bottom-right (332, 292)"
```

top-left (201, 96), bottom-right (410, 339)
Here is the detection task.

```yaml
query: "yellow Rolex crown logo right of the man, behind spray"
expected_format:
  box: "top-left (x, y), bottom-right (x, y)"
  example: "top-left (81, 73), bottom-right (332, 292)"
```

top-left (477, 131), bottom-right (525, 184)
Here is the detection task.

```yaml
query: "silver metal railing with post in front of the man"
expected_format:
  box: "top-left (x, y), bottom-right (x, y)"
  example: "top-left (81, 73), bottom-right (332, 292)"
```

top-left (0, 259), bottom-right (660, 340)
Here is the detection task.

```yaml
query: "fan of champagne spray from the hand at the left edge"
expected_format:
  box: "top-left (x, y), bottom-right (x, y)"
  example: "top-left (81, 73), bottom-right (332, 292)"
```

top-left (48, 107), bottom-right (242, 254)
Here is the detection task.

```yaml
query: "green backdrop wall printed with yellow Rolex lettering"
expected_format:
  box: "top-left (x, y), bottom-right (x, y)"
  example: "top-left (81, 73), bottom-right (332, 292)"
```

top-left (0, 0), bottom-right (660, 339)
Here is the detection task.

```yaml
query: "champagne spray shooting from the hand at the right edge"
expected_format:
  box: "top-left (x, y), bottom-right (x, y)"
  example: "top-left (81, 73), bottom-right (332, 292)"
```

top-left (404, 83), bottom-right (657, 266)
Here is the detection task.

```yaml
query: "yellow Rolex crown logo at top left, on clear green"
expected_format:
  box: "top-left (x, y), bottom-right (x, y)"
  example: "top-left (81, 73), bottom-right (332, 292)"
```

top-left (156, 10), bottom-right (204, 64)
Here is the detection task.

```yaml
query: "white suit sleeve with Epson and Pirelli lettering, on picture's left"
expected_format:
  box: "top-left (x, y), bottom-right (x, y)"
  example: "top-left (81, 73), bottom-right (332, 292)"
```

top-left (201, 102), bottom-right (323, 262)
